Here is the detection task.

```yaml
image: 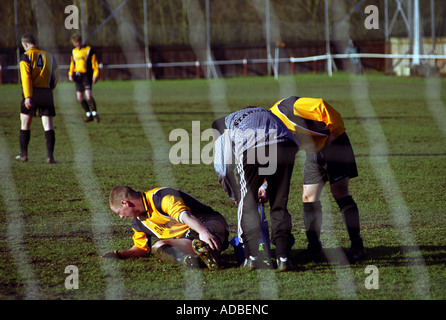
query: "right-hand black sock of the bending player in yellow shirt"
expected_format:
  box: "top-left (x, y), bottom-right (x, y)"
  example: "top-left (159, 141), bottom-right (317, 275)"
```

top-left (337, 196), bottom-right (363, 248)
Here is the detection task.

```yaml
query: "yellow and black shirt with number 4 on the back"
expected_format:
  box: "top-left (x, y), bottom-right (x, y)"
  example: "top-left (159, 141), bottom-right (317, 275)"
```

top-left (20, 47), bottom-right (57, 99)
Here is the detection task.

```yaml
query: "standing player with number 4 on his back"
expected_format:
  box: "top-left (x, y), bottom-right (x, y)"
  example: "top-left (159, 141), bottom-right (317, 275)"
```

top-left (15, 33), bottom-right (57, 163)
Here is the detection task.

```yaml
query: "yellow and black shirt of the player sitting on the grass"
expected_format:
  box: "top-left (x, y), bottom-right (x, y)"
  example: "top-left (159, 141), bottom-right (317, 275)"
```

top-left (132, 187), bottom-right (227, 251)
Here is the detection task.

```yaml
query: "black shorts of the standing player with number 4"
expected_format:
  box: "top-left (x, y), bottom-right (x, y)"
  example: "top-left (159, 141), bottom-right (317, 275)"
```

top-left (20, 88), bottom-right (56, 117)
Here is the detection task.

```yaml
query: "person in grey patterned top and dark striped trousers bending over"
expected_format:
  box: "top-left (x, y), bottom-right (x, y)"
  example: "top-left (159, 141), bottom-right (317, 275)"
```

top-left (212, 107), bottom-right (299, 272)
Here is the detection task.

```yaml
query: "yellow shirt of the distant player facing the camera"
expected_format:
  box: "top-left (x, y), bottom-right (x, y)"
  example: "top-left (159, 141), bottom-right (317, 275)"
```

top-left (68, 45), bottom-right (99, 78)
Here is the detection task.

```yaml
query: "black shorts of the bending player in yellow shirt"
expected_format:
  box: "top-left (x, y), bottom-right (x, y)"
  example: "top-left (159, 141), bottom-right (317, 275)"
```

top-left (303, 132), bottom-right (358, 184)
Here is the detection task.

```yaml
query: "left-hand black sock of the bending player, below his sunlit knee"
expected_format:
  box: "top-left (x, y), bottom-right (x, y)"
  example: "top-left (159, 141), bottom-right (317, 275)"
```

top-left (303, 201), bottom-right (322, 250)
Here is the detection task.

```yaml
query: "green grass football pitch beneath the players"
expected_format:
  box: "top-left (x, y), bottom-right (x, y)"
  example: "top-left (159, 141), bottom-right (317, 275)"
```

top-left (0, 74), bottom-right (446, 300)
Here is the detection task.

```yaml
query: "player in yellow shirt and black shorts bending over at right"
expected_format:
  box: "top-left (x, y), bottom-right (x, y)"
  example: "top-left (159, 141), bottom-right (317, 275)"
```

top-left (271, 96), bottom-right (365, 262)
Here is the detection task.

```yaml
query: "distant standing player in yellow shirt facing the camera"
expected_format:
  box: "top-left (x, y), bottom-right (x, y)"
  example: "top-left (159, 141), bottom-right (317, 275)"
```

top-left (68, 34), bottom-right (99, 122)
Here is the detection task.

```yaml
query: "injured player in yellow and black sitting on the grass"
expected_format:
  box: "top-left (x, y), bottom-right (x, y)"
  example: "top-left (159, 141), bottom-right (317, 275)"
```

top-left (103, 186), bottom-right (229, 269)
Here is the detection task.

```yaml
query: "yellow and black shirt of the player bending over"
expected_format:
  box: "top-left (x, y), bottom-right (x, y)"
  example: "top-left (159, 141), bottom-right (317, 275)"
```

top-left (270, 96), bottom-right (345, 152)
